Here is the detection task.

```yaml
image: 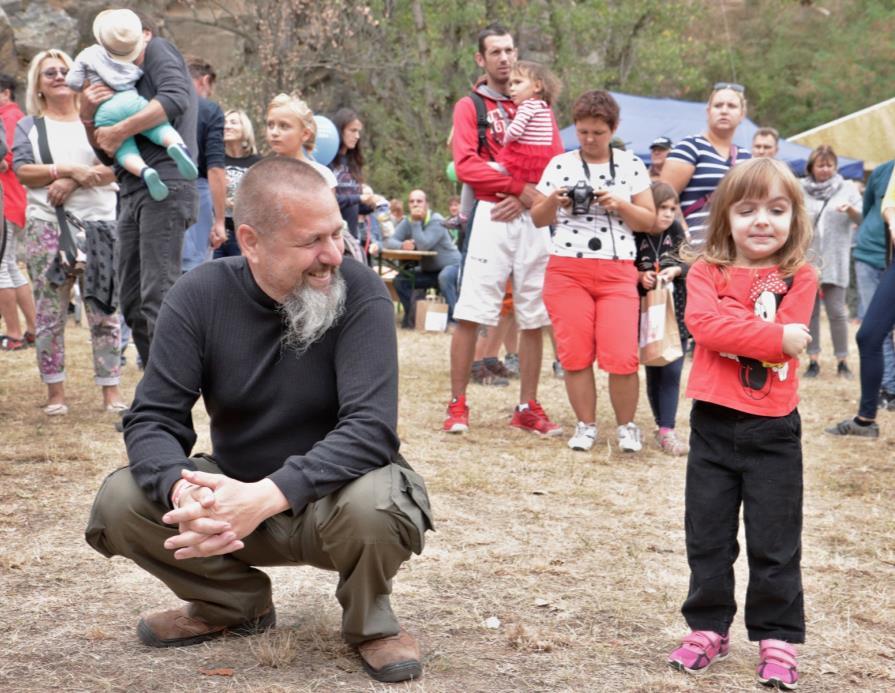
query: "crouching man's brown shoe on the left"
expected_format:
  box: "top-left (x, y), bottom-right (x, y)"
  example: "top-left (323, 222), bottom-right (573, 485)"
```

top-left (137, 605), bottom-right (277, 647)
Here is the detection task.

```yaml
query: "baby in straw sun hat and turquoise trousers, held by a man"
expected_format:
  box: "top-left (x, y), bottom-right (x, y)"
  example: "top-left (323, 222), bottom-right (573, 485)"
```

top-left (65, 9), bottom-right (198, 200)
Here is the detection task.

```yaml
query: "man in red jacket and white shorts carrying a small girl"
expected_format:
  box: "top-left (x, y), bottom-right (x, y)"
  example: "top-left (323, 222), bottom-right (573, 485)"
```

top-left (443, 23), bottom-right (562, 436)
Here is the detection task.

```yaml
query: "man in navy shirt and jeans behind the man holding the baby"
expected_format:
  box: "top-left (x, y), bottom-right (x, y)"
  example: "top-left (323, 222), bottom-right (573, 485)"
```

top-left (181, 55), bottom-right (227, 272)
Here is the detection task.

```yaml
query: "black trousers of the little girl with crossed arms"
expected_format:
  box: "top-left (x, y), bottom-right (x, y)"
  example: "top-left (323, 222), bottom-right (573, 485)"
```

top-left (681, 401), bottom-right (805, 643)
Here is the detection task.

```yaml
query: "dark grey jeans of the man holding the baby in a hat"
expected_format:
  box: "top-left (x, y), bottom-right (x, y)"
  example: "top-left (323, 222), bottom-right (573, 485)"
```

top-left (118, 181), bottom-right (198, 366)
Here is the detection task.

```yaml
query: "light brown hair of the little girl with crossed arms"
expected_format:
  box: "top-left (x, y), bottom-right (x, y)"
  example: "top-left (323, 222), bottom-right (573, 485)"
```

top-left (682, 158), bottom-right (812, 277)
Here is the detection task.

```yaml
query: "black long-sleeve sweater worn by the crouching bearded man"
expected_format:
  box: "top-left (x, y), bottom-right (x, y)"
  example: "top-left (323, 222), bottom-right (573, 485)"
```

top-left (124, 257), bottom-right (400, 513)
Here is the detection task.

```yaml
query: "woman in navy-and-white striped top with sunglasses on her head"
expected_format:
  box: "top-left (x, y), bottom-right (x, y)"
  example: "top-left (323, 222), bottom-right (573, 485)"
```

top-left (660, 82), bottom-right (752, 247)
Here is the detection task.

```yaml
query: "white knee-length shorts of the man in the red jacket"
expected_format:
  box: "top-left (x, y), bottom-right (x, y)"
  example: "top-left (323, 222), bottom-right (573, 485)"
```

top-left (454, 202), bottom-right (550, 330)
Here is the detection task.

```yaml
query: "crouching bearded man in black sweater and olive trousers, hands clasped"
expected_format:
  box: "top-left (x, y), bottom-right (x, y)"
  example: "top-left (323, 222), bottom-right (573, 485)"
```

top-left (86, 158), bottom-right (432, 682)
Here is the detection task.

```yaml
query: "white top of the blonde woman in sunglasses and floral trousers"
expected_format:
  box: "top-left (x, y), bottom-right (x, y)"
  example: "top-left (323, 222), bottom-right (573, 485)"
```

top-left (13, 116), bottom-right (118, 221)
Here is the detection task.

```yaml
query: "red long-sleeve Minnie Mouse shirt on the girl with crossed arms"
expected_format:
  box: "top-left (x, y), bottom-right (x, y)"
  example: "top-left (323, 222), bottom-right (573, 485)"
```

top-left (685, 260), bottom-right (817, 416)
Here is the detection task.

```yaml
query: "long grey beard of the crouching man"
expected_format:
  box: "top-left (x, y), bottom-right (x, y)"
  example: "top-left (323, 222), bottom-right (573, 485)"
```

top-left (280, 269), bottom-right (348, 354)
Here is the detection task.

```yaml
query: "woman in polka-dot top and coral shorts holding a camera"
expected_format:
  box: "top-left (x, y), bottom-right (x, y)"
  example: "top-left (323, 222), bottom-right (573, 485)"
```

top-left (531, 90), bottom-right (656, 452)
